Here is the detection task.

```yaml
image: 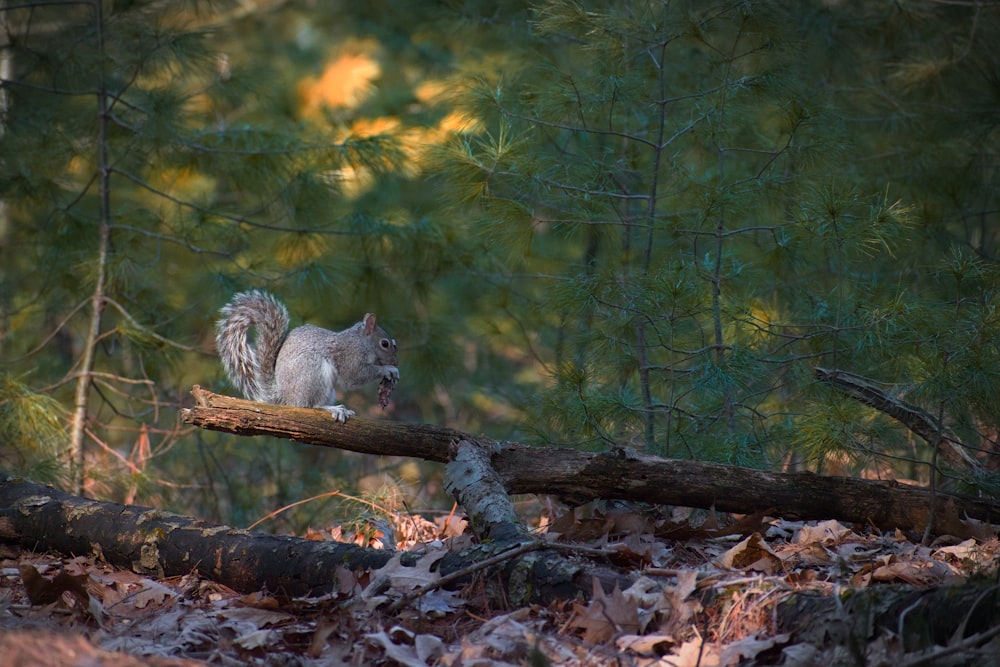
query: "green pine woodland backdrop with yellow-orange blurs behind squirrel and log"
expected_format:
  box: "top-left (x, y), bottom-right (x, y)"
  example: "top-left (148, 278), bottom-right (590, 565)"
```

top-left (0, 0), bottom-right (1000, 531)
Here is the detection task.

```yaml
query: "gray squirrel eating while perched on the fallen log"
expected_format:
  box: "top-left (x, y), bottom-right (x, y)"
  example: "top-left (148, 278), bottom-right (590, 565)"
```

top-left (215, 290), bottom-right (399, 423)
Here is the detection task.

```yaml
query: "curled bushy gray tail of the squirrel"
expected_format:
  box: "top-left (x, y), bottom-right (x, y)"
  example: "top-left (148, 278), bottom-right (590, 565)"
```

top-left (215, 290), bottom-right (288, 402)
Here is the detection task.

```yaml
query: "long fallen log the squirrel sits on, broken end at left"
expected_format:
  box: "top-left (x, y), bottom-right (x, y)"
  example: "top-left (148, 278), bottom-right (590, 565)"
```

top-left (182, 387), bottom-right (1000, 538)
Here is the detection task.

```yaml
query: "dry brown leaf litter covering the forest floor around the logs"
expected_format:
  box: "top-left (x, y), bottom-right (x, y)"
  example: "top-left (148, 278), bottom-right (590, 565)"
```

top-left (0, 504), bottom-right (1000, 667)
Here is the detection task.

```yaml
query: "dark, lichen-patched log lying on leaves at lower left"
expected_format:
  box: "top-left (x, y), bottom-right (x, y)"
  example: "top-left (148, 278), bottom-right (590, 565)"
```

top-left (0, 474), bottom-right (392, 595)
